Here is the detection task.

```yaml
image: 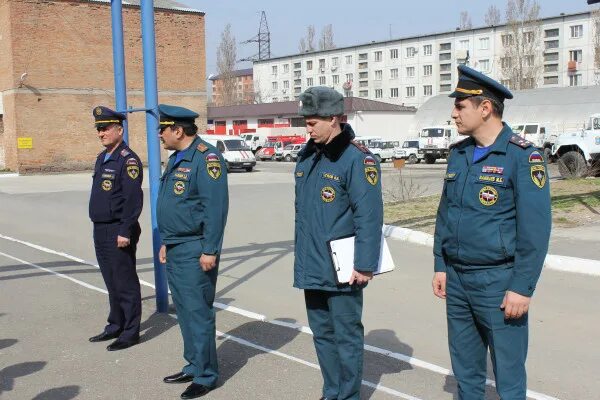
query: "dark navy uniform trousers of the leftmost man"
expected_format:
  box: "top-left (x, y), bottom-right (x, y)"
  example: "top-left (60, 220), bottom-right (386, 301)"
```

top-left (94, 223), bottom-right (142, 342)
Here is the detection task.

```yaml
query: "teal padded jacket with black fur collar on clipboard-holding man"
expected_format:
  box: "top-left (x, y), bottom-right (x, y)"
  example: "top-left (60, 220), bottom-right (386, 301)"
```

top-left (294, 124), bottom-right (383, 291)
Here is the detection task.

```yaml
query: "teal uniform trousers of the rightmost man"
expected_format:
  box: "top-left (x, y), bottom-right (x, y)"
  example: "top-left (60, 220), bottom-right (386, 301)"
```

top-left (446, 267), bottom-right (528, 400)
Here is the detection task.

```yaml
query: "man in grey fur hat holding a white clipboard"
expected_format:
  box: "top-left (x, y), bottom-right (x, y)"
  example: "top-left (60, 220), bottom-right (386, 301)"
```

top-left (294, 87), bottom-right (383, 400)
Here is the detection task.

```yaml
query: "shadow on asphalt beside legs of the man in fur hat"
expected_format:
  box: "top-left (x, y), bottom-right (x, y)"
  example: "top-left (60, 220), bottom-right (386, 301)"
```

top-left (361, 329), bottom-right (413, 399)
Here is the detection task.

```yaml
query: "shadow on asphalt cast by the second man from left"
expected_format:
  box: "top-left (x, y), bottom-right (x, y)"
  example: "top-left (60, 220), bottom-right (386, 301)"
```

top-left (217, 318), bottom-right (300, 386)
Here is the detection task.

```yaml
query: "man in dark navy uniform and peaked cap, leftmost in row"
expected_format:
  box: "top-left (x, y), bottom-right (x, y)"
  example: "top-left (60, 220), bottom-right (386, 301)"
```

top-left (90, 106), bottom-right (143, 351)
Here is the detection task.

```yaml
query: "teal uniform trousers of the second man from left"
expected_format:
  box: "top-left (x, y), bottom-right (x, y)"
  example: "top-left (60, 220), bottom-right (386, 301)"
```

top-left (167, 241), bottom-right (219, 388)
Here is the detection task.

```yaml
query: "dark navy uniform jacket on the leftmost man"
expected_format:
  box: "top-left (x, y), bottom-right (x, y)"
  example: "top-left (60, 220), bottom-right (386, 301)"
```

top-left (89, 142), bottom-right (144, 238)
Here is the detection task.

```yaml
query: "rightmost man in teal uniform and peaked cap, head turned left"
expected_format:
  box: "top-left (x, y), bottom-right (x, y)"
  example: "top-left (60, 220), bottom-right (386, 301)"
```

top-left (433, 65), bottom-right (551, 400)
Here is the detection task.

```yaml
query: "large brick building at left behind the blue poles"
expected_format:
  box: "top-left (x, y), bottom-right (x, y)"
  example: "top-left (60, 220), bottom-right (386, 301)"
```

top-left (0, 0), bottom-right (206, 173)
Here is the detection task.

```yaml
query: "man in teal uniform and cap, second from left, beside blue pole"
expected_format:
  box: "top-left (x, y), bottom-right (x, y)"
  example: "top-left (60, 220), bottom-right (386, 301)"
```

top-left (157, 104), bottom-right (229, 399)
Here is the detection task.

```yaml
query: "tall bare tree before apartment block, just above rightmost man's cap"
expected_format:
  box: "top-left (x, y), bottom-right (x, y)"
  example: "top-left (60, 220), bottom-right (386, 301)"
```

top-left (500, 0), bottom-right (543, 90)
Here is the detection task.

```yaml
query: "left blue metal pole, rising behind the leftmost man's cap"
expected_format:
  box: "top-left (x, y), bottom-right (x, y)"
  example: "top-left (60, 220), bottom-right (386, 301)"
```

top-left (110, 0), bottom-right (129, 144)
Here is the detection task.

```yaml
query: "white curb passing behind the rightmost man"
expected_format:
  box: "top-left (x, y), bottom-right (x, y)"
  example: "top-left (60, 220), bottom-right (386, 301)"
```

top-left (383, 225), bottom-right (600, 276)
